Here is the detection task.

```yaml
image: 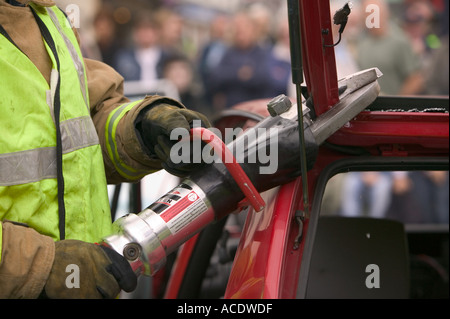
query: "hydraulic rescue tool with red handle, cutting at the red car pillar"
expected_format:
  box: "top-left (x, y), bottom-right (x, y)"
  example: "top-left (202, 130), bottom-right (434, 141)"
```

top-left (102, 68), bottom-right (381, 276)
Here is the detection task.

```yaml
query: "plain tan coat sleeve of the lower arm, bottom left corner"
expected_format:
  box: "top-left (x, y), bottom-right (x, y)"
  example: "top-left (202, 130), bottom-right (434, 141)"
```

top-left (0, 222), bottom-right (55, 299)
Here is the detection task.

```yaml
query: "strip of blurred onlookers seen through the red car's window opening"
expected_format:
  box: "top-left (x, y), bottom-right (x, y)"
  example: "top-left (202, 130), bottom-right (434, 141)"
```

top-left (322, 171), bottom-right (449, 225)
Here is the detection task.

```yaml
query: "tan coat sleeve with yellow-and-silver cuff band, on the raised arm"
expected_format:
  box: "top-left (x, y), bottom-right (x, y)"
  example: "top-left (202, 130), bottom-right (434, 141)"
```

top-left (85, 59), bottom-right (184, 184)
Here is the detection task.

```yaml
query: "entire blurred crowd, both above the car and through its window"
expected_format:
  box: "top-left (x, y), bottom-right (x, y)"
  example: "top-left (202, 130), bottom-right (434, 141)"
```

top-left (51, 0), bottom-right (449, 223)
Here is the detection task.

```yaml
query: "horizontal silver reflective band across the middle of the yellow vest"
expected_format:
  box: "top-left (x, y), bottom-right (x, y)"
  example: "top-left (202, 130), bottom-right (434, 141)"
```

top-left (0, 116), bottom-right (99, 186)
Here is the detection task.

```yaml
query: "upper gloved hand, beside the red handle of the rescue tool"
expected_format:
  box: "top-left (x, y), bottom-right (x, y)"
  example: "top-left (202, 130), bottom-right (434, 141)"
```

top-left (138, 104), bottom-right (211, 177)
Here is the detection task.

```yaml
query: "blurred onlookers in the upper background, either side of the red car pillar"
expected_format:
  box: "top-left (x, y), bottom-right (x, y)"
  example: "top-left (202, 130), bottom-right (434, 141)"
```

top-left (57, 0), bottom-right (449, 117)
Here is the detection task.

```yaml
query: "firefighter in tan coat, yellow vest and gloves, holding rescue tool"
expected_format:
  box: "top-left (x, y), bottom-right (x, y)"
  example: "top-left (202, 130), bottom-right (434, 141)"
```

top-left (0, 0), bottom-right (209, 298)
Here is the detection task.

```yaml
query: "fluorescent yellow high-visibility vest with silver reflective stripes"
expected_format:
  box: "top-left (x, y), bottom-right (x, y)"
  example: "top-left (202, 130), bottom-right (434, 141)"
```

top-left (0, 3), bottom-right (114, 258)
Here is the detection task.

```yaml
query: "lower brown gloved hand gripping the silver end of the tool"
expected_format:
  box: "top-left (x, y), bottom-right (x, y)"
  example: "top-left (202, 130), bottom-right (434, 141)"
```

top-left (41, 240), bottom-right (137, 299)
